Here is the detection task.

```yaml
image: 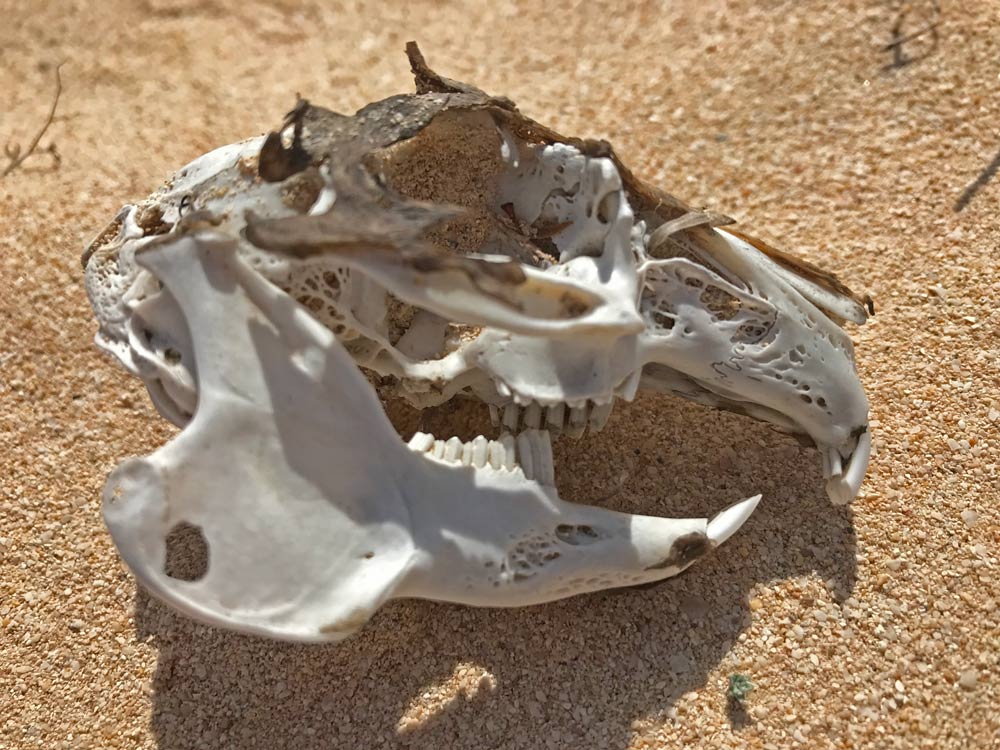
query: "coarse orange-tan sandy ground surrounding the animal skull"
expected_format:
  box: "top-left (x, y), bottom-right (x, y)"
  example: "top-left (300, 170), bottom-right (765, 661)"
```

top-left (0, 0), bottom-right (1000, 750)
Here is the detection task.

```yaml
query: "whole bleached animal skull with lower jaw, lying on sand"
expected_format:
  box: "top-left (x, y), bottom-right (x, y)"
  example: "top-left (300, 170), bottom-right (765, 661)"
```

top-left (84, 46), bottom-right (870, 640)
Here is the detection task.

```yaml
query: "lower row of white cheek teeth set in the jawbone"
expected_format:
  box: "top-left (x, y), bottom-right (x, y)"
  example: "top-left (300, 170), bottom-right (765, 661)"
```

top-left (409, 430), bottom-right (555, 485)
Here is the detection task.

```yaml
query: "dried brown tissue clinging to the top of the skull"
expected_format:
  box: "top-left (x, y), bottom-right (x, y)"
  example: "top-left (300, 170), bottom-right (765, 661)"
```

top-left (247, 42), bottom-right (872, 320)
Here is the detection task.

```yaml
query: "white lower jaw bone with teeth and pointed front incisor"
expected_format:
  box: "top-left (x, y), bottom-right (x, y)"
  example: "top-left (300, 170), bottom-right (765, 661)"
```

top-left (104, 231), bottom-right (759, 641)
